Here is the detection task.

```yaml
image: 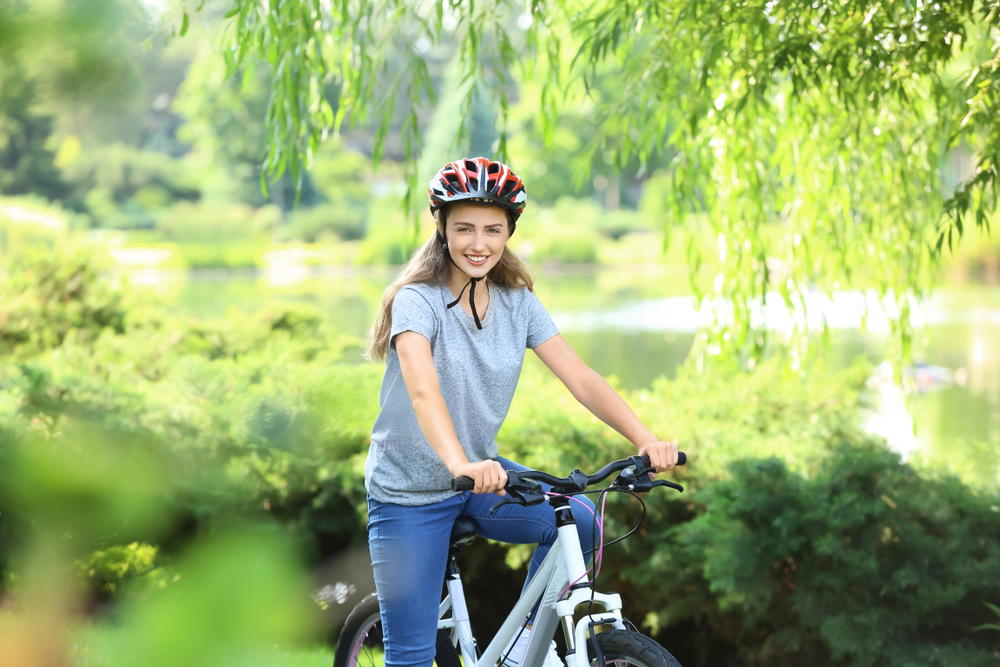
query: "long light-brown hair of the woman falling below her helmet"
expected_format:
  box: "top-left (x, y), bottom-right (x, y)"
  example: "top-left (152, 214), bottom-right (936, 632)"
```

top-left (365, 202), bottom-right (535, 361)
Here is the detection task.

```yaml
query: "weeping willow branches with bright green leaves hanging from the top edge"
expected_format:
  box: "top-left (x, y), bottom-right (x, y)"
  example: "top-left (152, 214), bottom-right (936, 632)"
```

top-left (195, 0), bottom-right (1000, 366)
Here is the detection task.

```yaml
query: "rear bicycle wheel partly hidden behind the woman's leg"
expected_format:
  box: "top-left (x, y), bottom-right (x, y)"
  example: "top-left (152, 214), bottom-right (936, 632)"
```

top-left (333, 593), bottom-right (462, 667)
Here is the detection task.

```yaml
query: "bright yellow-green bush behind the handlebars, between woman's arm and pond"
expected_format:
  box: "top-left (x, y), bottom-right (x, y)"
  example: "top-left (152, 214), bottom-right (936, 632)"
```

top-left (497, 359), bottom-right (868, 480)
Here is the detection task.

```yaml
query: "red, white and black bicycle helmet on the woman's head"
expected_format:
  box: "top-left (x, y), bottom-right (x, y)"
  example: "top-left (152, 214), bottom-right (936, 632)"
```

top-left (428, 157), bottom-right (528, 222)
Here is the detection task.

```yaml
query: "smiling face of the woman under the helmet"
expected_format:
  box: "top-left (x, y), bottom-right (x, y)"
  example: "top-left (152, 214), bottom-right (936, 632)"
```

top-left (444, 204), bottom-right (510, 278)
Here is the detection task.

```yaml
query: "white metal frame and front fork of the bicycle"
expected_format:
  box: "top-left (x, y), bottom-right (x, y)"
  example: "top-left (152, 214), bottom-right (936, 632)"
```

top-left (438, 523), bottom-right (626, 667)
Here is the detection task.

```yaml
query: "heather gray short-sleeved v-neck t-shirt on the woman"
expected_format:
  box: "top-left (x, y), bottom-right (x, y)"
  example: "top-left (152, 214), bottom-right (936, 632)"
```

top-left (365, 284), bottom-right (559, 505)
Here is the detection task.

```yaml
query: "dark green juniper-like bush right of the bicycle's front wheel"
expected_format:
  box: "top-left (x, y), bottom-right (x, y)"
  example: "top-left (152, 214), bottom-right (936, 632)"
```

top-left (622, 438), bottom-right (1000, 667)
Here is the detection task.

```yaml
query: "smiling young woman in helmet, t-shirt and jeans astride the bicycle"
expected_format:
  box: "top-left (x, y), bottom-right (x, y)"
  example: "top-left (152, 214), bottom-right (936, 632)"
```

top-left (365, 157), bottom-right (677, 667)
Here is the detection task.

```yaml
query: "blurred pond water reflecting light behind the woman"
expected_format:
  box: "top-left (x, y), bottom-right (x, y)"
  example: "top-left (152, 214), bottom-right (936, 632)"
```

top-left (133, 264), bottom-right (1000, 488)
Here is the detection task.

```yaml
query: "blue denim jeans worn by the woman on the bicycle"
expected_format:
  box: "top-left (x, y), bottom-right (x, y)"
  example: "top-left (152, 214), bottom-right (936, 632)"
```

top-left (368, 457), bottom-right (594, 667)
